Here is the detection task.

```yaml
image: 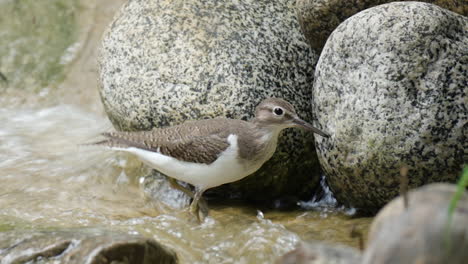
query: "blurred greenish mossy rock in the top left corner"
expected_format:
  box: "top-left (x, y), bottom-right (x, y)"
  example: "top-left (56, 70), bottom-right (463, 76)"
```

top-left (0, 0), bottom-right (78, 91)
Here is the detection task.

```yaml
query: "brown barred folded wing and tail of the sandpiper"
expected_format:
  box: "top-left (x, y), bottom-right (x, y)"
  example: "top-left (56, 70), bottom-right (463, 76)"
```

top-left (95, 119), bottom-right (238, 164)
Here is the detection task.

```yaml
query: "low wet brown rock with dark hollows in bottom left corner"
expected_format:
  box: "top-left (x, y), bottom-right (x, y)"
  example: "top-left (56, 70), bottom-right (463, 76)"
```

top-left (0, 229), bottom-right (177, 264)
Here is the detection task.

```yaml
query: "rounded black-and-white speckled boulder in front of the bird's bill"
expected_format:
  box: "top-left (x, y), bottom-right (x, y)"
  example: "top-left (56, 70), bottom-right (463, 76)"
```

top-left (313, 2), bottom-right (468, 211)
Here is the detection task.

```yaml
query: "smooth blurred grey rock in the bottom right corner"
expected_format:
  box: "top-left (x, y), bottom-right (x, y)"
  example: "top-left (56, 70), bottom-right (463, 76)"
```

top-left (363, 184), bottom-right (468, 264)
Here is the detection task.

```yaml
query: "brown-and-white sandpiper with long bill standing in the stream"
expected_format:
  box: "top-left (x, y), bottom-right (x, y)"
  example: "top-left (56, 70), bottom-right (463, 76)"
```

top-left (95, 98), bottom-right (329, 220)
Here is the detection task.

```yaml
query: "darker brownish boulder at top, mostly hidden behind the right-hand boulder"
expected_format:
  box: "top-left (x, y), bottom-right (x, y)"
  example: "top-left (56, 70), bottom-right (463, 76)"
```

top-left (297, 0), bottom-right (468, 52)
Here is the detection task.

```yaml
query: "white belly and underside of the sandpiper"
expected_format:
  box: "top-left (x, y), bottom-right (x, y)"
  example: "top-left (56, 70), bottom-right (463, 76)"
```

top-left (114, 135), bottom-right (262, 190)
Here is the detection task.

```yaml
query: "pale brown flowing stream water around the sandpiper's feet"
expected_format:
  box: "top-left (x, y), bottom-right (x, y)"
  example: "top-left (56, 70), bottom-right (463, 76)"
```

top-left (0, 0), bottom-right (371, 263)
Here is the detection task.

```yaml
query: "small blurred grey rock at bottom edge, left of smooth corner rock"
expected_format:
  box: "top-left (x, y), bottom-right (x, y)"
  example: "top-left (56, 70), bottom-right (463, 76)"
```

top-left (276, 241), bottom-right (362, 264)
